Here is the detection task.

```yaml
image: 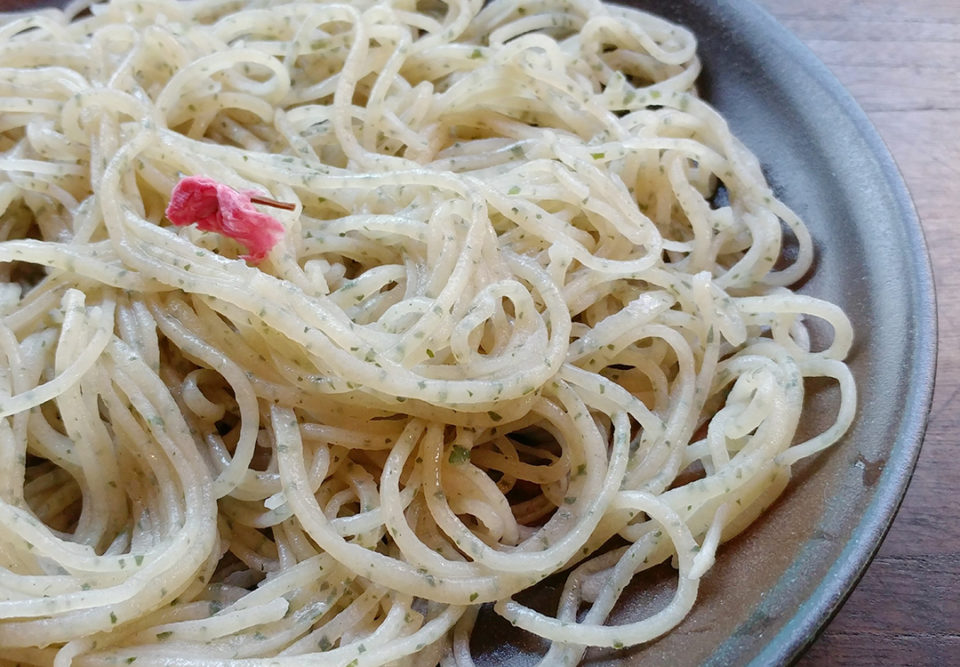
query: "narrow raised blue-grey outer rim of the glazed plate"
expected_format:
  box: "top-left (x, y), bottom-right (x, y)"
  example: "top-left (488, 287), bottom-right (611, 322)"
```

top-left (713, 0), bottom-right (938, 667)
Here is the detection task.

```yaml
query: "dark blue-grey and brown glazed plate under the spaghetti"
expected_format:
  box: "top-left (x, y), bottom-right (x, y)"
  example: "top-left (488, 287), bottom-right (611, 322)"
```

top-left (473, 0), bottom-right (936, 665)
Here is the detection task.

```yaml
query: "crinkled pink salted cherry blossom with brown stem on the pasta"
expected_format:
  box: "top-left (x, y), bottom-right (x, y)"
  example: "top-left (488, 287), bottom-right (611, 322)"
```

top-left (167, 176), bottom-right (294, 262)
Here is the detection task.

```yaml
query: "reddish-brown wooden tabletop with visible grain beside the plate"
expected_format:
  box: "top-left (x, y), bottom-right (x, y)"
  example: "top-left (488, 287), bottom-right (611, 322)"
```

top-left (758, 0), bottom-right (960, 667)
